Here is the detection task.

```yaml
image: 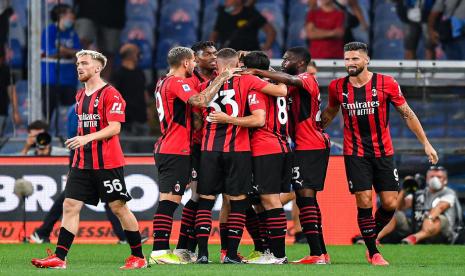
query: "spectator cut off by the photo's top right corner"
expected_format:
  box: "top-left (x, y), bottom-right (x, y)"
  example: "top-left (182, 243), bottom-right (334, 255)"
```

top-left (428, 0), bottom-right (465, 60)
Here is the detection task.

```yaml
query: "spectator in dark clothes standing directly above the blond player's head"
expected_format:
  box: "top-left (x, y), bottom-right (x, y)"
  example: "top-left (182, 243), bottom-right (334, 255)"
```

top-left (74, 0), bottom-right (126, 79)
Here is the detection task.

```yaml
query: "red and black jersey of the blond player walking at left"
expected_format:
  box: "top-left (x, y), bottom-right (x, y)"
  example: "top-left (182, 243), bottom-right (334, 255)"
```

top-left (72, 84), bottom-right (126, 170)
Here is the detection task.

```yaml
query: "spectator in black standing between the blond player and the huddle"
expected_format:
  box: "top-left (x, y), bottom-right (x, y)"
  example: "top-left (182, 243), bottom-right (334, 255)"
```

top-left (111, 43), bottom-right (149, 140)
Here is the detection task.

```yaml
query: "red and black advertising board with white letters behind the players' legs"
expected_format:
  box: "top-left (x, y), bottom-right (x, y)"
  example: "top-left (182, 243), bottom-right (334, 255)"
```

top-left (0, 156), bottom-right (359, 245)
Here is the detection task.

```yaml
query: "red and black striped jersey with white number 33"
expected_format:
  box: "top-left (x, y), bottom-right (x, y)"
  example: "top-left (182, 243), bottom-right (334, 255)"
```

top-left (200, 75), bottom-right (268, 152)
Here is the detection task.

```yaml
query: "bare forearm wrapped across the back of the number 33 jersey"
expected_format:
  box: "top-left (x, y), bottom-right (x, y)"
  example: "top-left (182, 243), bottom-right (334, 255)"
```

top-left (208, 109), bottom-right (266, 128)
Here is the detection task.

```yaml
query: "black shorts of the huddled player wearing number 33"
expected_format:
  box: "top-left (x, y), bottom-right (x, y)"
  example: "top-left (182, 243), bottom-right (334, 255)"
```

top-left (197, 151), bottom-right (252, 196)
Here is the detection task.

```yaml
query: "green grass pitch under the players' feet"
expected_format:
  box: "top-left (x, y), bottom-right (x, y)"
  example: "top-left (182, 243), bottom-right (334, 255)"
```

top-left (0, 244), bottom-right (465, 276)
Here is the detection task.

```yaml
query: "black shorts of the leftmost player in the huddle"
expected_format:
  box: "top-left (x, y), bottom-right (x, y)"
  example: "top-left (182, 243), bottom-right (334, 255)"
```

top-left (155, 153), bottom-right (191, 196)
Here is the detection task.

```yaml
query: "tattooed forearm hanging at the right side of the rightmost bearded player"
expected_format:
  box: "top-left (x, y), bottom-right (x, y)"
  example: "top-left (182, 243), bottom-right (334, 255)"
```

top-left (396, 103), bottom-right (439, 164)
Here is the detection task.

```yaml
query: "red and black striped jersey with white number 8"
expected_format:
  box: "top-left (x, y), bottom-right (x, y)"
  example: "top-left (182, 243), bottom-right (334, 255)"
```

top-left (249, 91), bottom-right (290, 156)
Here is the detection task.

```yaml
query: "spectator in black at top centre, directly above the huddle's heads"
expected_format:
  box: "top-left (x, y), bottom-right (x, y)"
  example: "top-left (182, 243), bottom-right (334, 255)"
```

top-left (210, 0), bottom-right (276, 51)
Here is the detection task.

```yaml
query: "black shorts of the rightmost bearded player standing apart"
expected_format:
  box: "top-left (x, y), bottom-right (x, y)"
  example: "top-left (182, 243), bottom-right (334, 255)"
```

top-left (344, 155), bottom-right (399, 193)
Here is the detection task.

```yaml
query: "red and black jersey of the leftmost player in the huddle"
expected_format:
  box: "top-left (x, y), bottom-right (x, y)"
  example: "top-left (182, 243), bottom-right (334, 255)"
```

top-left (154, 76), bottom-right (198, 155)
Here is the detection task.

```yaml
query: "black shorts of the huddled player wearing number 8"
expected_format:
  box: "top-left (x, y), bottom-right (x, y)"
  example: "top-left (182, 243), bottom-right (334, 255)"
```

top-left (252, 153), bottom-right (292, 195)
